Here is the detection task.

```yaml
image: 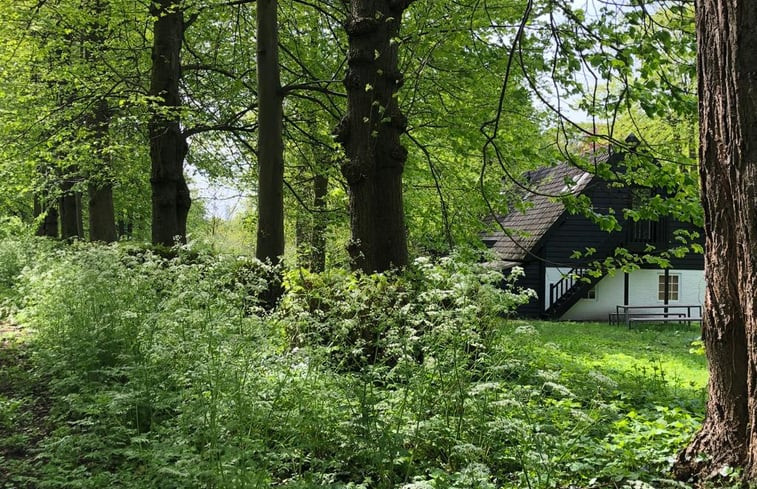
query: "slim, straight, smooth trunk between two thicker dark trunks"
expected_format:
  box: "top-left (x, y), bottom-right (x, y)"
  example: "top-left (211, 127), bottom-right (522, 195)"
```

top-left (255, 0), bottom-right (284, 265)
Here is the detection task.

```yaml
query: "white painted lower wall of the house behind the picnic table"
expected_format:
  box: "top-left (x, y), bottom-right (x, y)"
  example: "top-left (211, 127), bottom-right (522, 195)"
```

top-left (544, 268), bottom-right (705, 321)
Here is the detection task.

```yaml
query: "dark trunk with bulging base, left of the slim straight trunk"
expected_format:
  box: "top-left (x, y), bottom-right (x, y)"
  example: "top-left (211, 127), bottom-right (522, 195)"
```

top-left (150, 0), bottom-right (191, 246)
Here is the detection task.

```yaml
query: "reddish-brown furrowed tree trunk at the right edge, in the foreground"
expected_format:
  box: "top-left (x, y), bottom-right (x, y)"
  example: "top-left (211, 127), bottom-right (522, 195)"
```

top-left (674, 0), bottom-right (757, 479)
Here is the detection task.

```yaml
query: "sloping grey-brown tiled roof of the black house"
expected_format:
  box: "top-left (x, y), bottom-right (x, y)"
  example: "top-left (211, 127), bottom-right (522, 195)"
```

top-left (484, 160), bottom-right (606, 264)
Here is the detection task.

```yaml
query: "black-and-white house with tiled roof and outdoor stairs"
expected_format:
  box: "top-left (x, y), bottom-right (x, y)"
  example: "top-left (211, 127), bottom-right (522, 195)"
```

top-left (483, 148), bottom-right (705, 321)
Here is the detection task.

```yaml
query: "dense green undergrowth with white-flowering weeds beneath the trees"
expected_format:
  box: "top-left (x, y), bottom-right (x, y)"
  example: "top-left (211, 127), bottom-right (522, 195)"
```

top-left (0, 237), bottom-right (703, 489)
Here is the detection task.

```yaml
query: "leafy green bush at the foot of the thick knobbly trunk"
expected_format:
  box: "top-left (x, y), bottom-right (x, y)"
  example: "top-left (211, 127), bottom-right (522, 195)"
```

top-left (279, 257), bottom-right (533, 370)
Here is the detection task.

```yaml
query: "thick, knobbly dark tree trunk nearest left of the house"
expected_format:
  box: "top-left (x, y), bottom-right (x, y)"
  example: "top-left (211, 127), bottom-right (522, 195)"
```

top-left (337, 0), bottom-right (411, 273)
